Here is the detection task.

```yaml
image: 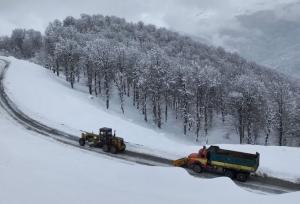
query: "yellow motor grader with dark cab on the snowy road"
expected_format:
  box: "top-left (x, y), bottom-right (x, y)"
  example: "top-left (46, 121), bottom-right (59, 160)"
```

top-left (79, 127), bottom-right (126, 154)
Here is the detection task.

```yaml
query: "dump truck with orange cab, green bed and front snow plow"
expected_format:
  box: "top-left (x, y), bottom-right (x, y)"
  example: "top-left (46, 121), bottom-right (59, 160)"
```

top-left (173, 146), bottom-right (259, 182)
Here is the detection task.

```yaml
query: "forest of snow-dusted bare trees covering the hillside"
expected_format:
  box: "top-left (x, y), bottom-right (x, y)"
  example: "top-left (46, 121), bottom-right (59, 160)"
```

top-left (0, 14), bottom-right (300, 146)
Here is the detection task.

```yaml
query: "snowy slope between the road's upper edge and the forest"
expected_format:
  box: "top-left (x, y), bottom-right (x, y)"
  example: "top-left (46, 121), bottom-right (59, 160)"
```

top-left (1, 58), bottom-right (300, 182)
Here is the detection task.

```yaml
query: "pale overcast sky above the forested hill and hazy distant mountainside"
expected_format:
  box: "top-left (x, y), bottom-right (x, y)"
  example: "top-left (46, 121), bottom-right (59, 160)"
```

top-left (0, 0), bottom-right (296, 40)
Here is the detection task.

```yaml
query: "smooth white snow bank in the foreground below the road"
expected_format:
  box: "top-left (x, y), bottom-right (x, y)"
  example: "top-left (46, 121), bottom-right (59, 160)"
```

top-left (0, 109), bottom-right (300, 204)
